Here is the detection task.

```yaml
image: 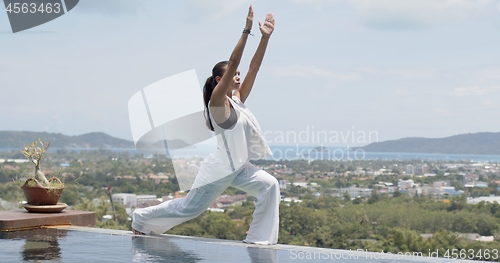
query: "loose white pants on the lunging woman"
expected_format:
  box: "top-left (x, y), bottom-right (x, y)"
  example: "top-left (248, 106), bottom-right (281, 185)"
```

top-left (132, 162), bottom-right (280, 245)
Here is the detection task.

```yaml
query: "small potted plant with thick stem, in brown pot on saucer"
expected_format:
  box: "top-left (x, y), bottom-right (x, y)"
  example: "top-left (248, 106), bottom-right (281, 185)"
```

top-left (21, 139), bottom-right (66, 212)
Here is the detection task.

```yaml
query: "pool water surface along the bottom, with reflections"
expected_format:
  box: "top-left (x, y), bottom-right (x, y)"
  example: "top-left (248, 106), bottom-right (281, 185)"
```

top-left (0, 226), bottom-right (484, 263)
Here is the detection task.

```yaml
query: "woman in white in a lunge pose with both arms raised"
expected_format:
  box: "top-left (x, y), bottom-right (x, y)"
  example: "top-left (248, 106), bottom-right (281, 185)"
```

top-left (132, 6), bottom-right (280, 245)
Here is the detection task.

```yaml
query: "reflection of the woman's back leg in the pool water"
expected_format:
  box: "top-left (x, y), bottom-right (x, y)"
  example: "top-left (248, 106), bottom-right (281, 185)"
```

top-left (132, 236), bottom-right (201, 263)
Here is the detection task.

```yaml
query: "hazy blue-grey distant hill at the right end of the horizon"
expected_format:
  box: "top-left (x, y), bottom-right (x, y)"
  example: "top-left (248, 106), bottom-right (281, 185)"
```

top-left (359, 132), bottom-right (500, 155)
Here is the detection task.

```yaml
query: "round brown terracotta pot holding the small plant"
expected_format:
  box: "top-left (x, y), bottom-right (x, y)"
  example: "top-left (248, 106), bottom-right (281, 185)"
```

top-left (21, 177), bottom-right (64, 205)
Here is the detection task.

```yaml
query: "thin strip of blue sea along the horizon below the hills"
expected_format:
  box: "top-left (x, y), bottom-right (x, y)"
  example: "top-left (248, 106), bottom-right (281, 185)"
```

top-left (0, 145), bottom-right (500, 162)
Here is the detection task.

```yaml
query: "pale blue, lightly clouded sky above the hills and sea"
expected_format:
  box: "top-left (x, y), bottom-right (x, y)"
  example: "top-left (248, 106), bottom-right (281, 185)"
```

top-left (0, 0), bottom-right (500, 146)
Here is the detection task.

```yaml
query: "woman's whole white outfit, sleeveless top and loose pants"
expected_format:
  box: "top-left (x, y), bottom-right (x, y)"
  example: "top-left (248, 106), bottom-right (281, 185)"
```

top-left (132, 96), bottom-right (280, 245)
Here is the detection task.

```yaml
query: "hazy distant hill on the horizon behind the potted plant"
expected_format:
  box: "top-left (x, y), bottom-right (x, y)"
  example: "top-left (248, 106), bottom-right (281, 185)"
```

top-left (0, 131), bottom-right (134, 148)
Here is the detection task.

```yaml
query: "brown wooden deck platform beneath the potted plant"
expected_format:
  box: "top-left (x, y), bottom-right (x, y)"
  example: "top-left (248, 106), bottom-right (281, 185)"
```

top-left (0, 210), bottom-right (96, 231)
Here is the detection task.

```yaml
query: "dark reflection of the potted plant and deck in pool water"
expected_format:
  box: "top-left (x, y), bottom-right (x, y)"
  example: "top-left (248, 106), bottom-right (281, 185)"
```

top-left (0, 229), bottom-right (66, 261)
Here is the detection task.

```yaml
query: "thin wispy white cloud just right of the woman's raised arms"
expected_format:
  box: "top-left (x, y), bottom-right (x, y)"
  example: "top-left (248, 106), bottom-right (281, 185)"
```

top-left (271, 65), bottom-right (358, 80)
